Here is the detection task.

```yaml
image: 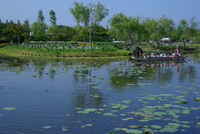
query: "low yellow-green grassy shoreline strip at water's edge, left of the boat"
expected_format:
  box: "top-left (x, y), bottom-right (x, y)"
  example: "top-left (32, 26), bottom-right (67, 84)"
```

top-left (0, 48), bottom-right (129, 60)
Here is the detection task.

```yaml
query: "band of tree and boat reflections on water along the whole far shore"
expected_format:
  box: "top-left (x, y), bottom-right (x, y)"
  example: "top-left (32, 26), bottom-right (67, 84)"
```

top-left (0, 54), bottom-right (199, 88)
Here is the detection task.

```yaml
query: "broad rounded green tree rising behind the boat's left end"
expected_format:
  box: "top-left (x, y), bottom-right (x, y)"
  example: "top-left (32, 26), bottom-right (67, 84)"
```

top-left (109, 13), bottom-right (144, 50)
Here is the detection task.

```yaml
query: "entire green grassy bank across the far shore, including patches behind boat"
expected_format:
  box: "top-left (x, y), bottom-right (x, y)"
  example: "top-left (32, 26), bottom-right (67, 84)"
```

top-left (0, 44), bottom-right (200, 60)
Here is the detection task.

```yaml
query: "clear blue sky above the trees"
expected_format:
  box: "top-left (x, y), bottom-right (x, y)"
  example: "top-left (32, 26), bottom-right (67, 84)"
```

top-left (0, 0), bottom-right (200, 26)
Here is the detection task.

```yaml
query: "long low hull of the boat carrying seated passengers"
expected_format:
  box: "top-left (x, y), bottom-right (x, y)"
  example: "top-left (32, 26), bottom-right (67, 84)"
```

top-left (131, 56), bottom-right (186, 61)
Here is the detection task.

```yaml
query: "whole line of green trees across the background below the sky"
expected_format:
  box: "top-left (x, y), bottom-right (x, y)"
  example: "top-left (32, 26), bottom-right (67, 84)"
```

top-left (0, 2), bottom-right (200, 51)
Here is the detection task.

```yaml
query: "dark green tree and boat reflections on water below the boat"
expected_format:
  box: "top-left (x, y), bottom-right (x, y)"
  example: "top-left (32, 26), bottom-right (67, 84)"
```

top-left (109, 61), bottom-right (196, 87)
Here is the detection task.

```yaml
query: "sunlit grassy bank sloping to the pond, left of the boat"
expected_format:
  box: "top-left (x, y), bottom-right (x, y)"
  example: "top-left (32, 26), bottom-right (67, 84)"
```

top-left (0, 45), bottom-right (129, 59)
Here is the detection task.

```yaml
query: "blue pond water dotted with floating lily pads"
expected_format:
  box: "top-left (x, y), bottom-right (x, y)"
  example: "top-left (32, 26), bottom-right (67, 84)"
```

top-left (0, 54), bottom-right (200, 134)
